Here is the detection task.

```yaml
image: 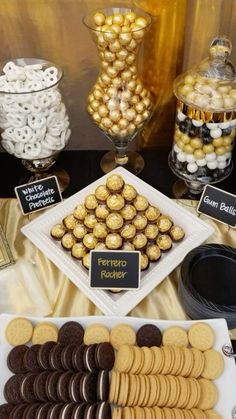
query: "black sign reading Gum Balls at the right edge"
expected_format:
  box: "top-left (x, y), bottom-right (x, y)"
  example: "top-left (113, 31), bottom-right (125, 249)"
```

top-left (197, 185), bottom-right (236, 228)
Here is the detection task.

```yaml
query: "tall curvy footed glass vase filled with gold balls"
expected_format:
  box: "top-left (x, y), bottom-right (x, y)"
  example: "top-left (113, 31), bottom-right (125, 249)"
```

top-left (84, 7), bottom-right (153, 174)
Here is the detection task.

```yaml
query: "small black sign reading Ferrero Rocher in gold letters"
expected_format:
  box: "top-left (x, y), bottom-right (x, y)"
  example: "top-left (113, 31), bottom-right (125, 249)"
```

top-left (90, 250), bottom-right (140, 290)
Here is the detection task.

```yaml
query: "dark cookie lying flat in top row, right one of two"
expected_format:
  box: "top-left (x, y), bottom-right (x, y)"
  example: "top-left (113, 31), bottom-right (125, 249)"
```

top-left (136, 324), bottom-right (162, 348)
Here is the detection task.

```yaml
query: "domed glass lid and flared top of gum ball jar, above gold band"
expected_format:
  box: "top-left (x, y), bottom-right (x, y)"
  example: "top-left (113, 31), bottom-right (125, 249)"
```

top-left (174, 35), bottom-right (236, 112)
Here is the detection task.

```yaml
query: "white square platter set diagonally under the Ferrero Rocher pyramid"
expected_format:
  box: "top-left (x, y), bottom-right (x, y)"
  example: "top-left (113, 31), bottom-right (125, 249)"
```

top-left (21, 168), bottom-right (214, 316)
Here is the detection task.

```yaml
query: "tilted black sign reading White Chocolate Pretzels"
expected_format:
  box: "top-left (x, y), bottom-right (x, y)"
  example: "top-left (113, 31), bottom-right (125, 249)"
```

top-left (15, 176), bottom-right (62, 215)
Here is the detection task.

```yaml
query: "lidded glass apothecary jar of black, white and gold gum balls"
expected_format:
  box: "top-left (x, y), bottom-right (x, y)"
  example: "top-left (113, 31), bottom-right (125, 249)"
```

top-left (169, 36), bottom-right (236, 194)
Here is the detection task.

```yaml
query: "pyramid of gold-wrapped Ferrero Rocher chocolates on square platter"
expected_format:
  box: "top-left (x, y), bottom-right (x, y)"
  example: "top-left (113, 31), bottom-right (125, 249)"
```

top-left (51, 174), bottom-right (185, 270)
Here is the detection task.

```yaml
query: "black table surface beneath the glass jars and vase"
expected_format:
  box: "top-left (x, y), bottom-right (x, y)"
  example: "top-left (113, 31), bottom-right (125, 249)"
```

top-left (0, 148), bottom-right (236, 198)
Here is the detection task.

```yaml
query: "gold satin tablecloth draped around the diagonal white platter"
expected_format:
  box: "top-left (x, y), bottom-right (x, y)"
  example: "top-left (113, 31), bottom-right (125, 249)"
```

top-left (0, 199), bottom-right (236, 338)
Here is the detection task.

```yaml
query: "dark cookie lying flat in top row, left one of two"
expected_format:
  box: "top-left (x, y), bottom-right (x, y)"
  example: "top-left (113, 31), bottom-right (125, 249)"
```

top-left (58, 321), bottom-right (84, 345)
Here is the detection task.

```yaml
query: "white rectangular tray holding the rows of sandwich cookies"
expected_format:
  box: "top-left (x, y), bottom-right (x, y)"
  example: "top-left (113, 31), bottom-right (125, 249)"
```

top-left (0, 314), bottom-right (236, 419)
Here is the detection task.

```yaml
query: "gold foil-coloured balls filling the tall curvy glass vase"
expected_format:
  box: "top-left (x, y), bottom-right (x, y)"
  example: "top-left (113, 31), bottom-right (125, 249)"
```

top-left (88, 11), bottom-right (152, 137)
